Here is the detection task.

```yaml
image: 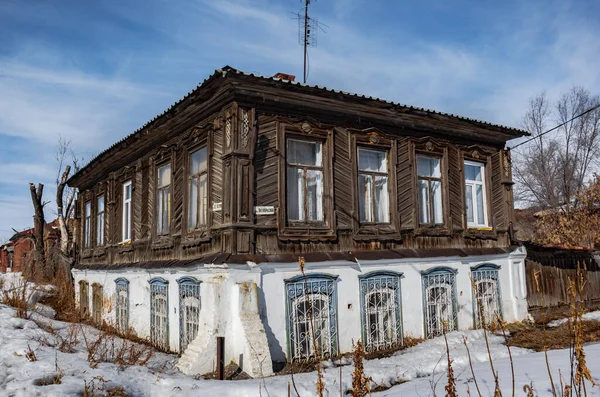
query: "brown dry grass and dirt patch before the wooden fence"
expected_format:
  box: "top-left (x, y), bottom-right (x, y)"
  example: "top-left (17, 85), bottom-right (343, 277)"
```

top-left (508, 320), bottom-right (600, 351)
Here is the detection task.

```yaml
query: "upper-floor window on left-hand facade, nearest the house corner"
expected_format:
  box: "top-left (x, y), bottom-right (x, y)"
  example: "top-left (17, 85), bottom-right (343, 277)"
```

top-left (188, 147), bottom-right (208, 229)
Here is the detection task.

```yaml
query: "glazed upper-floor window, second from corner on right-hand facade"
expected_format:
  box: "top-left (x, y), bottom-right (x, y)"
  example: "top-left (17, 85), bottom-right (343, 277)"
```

top-left (358, 148), bottom-right (390, 223)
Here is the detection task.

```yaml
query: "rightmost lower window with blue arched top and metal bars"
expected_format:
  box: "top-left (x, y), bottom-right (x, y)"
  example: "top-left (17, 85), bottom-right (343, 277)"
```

top-left (471, 263), bottom-right (502, 328)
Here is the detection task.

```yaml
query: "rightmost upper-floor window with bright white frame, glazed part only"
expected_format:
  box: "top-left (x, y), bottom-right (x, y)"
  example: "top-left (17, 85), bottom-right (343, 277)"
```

top-left (465, 160), bottom-right (488, 227)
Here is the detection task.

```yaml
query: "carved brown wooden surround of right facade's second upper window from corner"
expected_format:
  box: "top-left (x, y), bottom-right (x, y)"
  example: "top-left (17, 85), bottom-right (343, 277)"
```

top-left (350, 129), bottom-right (400, 240)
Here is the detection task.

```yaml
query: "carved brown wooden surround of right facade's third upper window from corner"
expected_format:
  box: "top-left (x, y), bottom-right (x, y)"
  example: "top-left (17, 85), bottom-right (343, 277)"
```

top-left (410, 138), bottom-right (451, 235)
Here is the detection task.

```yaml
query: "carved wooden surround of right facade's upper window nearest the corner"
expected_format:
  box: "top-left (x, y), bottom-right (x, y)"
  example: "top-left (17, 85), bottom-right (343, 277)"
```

top-left (277, 121), bottom-right (335, 240)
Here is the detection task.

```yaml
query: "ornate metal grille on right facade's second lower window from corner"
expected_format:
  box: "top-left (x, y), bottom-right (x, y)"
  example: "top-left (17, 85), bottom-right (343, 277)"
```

top-left (360, 272), bottom-right (402, 352)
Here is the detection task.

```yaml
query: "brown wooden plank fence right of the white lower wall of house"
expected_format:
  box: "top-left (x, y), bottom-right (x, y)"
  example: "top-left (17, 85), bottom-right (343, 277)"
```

top-left (525, 260), bottom-right (600, 309)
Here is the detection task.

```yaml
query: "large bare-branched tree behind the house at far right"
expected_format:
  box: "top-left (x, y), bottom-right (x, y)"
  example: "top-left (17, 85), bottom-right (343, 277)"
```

top-left (514, 87), bottom-right (600, 213)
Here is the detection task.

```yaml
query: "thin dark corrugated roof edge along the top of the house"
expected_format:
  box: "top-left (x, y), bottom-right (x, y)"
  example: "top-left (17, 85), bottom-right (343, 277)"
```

top-left (69, 66), bottom-right (529, 182)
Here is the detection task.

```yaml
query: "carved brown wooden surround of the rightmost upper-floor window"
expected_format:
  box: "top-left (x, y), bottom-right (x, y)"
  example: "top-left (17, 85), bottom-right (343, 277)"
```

top-left (460, 146), bottom-right (496, 234)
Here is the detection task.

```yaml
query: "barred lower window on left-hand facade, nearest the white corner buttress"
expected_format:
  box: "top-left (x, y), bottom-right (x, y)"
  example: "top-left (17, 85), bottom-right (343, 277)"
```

top-left (177, 277), bottom-right (200, 352)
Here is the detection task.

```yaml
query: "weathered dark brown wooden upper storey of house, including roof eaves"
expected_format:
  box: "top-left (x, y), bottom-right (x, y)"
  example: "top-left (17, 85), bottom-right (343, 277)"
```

top-left (69, 67), bottom-right (526, 267)
